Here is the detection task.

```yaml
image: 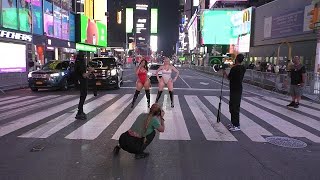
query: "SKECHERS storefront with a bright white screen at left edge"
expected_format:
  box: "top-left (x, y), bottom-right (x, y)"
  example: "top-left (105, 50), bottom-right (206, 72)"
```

top-left (0, 28), bottom-right (32, 87)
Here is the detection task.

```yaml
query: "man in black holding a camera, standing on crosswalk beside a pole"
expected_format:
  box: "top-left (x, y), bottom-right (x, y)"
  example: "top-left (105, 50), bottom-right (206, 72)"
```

top-left (223, 54), bottom-right (246, 131)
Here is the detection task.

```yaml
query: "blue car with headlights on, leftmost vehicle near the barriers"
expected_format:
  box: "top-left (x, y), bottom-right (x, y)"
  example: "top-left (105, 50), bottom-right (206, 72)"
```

top-left (28, 60), bottom-right (75, 91)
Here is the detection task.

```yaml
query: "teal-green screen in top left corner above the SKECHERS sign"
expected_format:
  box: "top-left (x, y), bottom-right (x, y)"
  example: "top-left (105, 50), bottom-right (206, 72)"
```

top-left (0, 0), bottom-right (18, 30)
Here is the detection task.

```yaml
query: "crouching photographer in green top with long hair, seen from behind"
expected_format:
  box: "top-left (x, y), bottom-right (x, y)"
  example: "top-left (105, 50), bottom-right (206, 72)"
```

top-left (113, 103), bottom-right (165, 159)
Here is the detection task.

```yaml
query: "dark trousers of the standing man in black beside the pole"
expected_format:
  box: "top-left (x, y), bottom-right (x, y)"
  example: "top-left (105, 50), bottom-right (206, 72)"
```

top-left (229, 90), bottom-right (242, 127)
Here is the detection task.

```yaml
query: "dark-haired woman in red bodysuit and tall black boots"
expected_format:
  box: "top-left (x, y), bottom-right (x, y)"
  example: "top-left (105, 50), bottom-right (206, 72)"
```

top-left (131, 59), bottom-right (150, 108)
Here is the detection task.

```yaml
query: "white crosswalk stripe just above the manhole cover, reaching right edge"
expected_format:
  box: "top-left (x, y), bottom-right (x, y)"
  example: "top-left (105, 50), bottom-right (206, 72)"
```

top-left (231, 97), bottom-right (320, 143)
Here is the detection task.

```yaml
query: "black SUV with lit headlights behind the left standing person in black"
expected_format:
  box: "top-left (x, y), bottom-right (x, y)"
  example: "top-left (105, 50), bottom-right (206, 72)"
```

top-left (88, 57), bottom-right (123, 89)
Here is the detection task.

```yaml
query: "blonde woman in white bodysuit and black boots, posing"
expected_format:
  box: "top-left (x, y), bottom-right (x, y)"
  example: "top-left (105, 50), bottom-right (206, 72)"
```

top-left (156, 57), bottom-right (179, 107)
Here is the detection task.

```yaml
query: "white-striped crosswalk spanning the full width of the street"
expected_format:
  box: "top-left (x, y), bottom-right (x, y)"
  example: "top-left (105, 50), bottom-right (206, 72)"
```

top-left (0, 94), bottom-right (320, 143)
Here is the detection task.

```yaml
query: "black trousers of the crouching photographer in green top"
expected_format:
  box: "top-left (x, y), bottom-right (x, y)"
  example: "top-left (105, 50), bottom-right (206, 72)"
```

top-left (119, 131), bottom-right (156, 154)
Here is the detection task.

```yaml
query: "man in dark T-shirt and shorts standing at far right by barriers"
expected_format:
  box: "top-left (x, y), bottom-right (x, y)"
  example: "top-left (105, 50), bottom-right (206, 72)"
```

top-left (287, 56), bottom-right (306, 108)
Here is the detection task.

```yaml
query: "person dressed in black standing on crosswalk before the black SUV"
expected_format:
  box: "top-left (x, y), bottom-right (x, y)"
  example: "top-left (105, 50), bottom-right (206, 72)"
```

top-left (75, 51), bottom-right (93, 120)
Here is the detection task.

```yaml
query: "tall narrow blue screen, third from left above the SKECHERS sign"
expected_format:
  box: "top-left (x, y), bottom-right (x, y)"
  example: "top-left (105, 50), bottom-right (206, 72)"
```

top-left (29, 0), bottom-right (43, 35)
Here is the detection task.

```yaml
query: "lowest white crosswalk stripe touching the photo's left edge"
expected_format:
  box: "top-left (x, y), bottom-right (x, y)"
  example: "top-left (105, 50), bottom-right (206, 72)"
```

top-left (0, 95), bottom-right (93, 137)
